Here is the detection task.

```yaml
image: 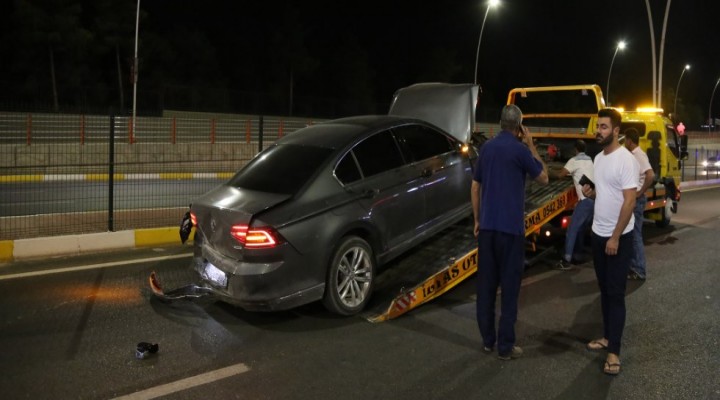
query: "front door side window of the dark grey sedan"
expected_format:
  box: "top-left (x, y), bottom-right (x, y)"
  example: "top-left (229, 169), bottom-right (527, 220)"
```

top-left (393, 125), bottom-right (453, 161)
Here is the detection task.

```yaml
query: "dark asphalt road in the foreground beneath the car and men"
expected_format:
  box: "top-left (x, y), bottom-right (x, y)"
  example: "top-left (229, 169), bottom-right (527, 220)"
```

top-left (0, 188), bottom-right (720, 400)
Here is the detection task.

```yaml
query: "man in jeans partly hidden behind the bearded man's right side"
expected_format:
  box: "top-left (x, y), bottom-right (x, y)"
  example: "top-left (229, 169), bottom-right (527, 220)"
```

top-left (625, 128), bottom-right (655, 280)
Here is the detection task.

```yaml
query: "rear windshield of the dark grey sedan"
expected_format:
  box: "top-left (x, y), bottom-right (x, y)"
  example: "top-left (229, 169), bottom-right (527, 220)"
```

top-left (228, 144), bottom-right (333, 195)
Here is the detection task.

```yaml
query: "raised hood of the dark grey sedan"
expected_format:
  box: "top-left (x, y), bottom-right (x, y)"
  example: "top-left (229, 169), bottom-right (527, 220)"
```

top-left (388, 83), bottom-right (479, 143)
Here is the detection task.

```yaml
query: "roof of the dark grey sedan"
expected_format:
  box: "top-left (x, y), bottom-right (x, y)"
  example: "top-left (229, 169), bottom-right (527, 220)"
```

top-left (277, 115), bottom-right (427, 149)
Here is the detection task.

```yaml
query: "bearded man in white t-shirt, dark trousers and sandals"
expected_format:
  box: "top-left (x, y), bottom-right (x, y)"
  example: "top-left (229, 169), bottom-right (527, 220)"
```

top-left (583, 108), bottom-right (639, 375)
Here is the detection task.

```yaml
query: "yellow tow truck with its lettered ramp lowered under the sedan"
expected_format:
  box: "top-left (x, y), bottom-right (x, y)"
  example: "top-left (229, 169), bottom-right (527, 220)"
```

top-left (149, 85), bottom-right (687, 322)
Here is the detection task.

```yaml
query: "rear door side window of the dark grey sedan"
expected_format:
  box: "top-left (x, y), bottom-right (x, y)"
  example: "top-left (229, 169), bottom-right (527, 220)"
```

top-left (352, 131), bottom-right (404, 178)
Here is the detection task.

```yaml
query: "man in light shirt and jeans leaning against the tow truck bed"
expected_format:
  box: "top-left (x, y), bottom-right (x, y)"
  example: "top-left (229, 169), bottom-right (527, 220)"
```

top-left (554, 139), bottom-right (595, 271)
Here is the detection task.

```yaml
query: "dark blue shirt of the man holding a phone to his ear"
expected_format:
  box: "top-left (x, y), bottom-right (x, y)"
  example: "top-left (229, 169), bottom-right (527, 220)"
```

top-left (473, 131), bottom-right (543, 236)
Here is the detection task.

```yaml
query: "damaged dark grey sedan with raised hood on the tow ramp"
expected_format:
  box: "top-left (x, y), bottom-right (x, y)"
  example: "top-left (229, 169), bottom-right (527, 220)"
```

top-left (150, 84), bottom-right (477, 315)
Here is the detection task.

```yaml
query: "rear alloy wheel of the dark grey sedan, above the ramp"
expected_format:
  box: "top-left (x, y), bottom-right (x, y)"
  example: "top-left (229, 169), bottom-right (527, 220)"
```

top-left (323, 236), bottom-right (375, 315)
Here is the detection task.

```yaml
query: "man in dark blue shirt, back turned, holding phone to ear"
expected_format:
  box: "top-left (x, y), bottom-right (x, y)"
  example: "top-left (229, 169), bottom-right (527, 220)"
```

top-left (470, 104), bottom-right (548, 360)
